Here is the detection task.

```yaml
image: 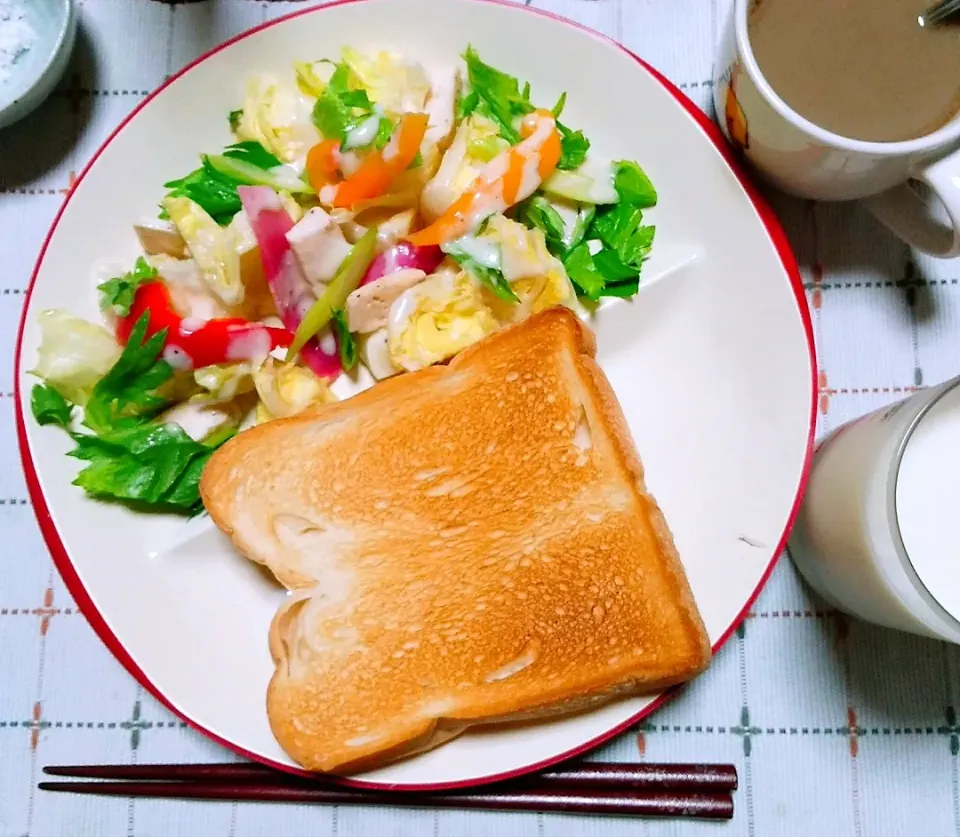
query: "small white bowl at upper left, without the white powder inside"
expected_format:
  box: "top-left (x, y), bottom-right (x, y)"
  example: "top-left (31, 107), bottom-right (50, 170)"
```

top-left (0, 0), bottom-right (77, 128)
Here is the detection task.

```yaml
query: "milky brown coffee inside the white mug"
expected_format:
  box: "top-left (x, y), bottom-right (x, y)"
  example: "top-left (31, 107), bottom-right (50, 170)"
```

top-left (747, 0), bottom-right (960, 142)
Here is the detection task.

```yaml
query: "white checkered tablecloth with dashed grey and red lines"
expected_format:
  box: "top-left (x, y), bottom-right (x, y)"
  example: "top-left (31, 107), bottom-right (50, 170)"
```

top-left (0, 0), bottom-right (960, 837)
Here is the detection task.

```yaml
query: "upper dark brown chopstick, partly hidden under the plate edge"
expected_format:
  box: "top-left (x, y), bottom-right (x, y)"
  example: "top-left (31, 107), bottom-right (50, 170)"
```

top-left (44, 762), bottom-right (737, 792)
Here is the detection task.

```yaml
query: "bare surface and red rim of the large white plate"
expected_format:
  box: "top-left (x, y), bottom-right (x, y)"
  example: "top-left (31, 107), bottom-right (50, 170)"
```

top-left (17, 0), bottom-right (816, 787)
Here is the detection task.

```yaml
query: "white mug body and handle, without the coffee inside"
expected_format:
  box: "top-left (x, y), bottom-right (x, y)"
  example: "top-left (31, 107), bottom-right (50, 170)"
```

top-left (713, 0), bottom-right (960, 258)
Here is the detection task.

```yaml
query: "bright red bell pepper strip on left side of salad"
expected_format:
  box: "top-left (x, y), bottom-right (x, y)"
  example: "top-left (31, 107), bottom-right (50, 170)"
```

top-left (116, 282), bottom-right (293, 369)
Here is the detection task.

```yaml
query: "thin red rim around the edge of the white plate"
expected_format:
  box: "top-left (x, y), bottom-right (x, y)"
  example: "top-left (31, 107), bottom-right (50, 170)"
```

top-left (14, 0), bottom-right (817, 791)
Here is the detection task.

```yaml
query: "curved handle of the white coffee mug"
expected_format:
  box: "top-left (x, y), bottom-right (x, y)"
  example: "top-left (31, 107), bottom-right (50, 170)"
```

top-left (864, 151), bottom-right (960, 259)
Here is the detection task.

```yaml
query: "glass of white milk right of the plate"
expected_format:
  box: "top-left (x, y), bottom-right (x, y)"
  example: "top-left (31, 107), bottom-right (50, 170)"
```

top-left (790, 377), bottom-right (960, 643)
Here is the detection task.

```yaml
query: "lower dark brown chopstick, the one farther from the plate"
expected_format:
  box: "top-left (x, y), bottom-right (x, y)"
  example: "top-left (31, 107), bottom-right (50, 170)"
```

top-left (40, 781), bottom-right (733, 819)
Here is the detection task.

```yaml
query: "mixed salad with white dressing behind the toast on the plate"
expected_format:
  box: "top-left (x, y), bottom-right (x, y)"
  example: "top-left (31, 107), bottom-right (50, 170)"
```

top-left (31, 47), bottom-right (657, 515)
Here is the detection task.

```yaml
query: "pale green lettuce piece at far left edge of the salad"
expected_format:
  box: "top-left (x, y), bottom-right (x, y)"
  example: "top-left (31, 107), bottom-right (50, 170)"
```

top-left (30, 309), bottom-right (120, 405)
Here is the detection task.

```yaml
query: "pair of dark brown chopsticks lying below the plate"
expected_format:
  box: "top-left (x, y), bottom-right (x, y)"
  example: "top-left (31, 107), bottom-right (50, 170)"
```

top-left (39, 762), bottom-right (737, 819)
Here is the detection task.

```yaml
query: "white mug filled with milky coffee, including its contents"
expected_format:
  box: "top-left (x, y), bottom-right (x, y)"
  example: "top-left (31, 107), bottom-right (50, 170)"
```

top-left (713, 0), bottom-right (960, 257)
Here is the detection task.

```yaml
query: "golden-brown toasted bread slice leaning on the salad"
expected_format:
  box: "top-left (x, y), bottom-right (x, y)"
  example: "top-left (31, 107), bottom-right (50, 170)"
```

top-left (201, 308), bottom-right (710, 772)
